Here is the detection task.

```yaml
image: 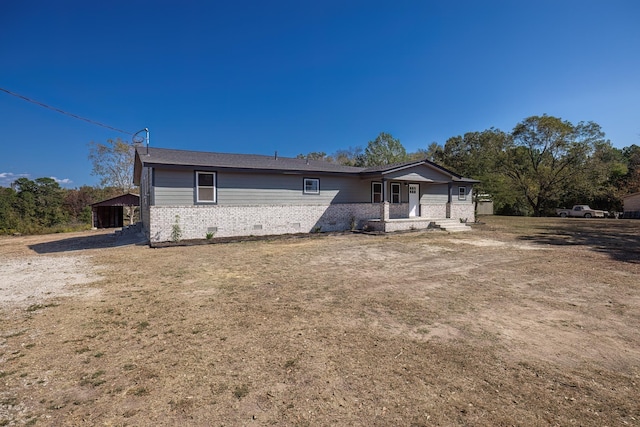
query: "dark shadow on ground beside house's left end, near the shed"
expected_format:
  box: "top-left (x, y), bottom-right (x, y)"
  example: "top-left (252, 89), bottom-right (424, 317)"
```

top-left (29, 233), bottom-right (146, 254)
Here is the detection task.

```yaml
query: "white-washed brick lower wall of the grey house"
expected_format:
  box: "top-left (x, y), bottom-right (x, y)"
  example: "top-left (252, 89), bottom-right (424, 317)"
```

top-left (143, 203), bottom-right (473, 242)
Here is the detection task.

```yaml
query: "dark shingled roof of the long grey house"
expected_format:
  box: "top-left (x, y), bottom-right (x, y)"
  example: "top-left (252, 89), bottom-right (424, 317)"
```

top-left (134, 147), bottom-right (478, 183)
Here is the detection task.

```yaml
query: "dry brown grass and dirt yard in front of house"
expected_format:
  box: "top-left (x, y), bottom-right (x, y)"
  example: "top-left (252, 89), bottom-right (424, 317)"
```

top-left (0, 217), bottom-right (640, 426)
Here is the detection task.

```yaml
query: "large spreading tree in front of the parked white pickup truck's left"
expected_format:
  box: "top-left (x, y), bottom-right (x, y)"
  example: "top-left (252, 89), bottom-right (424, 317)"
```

top-left (500, 115), bottom-right (604, 216)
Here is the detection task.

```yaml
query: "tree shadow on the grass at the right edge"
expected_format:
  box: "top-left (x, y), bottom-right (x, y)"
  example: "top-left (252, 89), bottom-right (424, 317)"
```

top-left (520, 220), bottom-right (640, 264)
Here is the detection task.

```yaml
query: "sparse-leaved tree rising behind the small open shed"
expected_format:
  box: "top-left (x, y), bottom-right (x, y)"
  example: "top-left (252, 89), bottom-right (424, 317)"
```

top-left (89, 138), bottom-right (135, 193)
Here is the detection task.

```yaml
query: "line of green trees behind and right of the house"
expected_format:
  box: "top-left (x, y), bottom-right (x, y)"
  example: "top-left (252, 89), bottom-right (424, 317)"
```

top-left (298, 115), bottom-right (640, 216)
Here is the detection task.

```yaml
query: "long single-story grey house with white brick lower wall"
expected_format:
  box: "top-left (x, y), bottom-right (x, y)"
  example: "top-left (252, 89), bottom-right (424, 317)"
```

top-left (134, 147), bottom-right (478, 242)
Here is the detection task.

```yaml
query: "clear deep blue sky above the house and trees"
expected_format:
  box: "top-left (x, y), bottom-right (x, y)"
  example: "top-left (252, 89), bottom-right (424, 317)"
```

top-left (0, 0), bottom-right (640, 187)
